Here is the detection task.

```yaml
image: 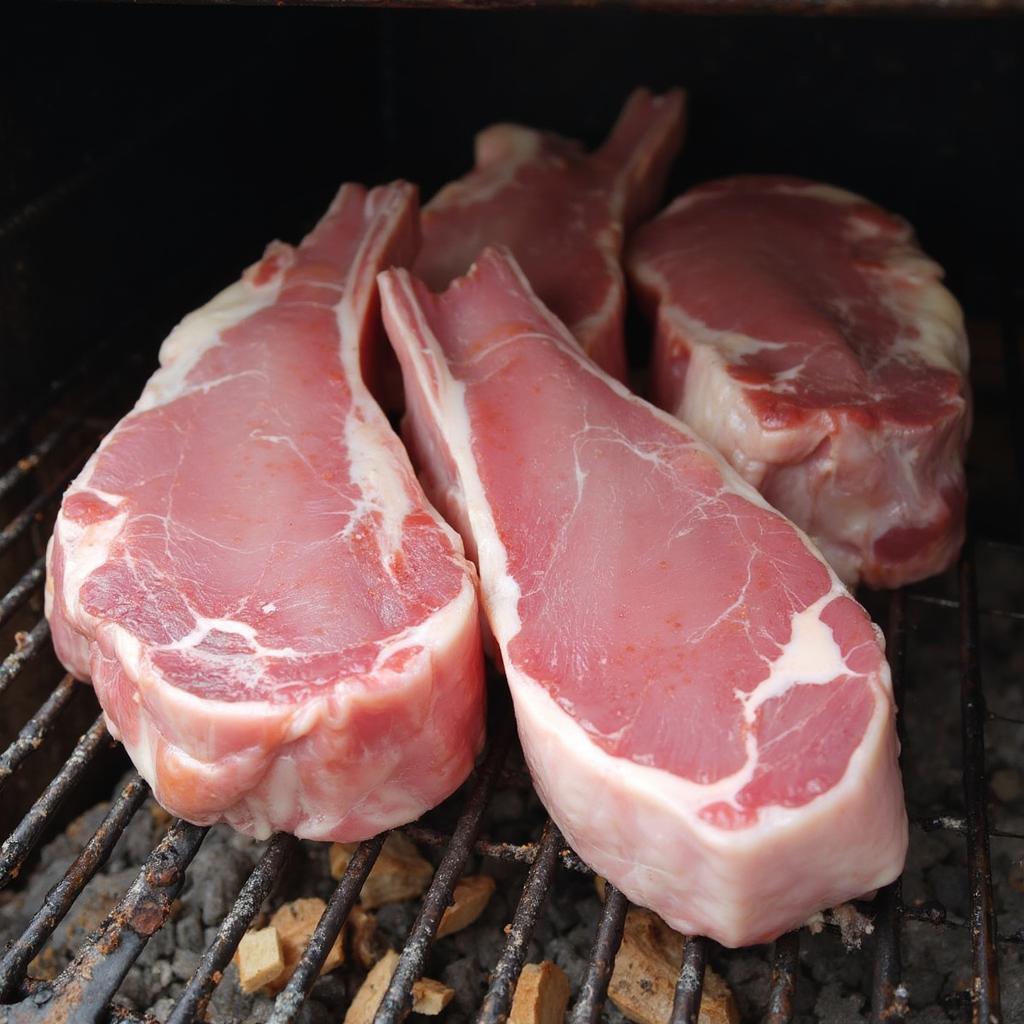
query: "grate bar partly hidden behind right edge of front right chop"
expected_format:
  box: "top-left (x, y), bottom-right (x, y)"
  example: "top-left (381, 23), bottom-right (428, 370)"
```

top-left (871, 590), bottom-right (908, 1024)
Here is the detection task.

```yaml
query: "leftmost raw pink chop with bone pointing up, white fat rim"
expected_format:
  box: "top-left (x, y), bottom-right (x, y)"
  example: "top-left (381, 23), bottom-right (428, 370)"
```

top-left (47, 184), bottom-right (483, 840)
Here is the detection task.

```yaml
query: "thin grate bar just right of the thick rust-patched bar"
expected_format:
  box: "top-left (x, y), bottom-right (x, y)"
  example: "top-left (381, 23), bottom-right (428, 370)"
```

top-left (167, 833), bottom-right (299, 1024)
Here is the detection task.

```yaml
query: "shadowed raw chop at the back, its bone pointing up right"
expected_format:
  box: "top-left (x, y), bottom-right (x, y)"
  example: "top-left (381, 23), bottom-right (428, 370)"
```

top-left (416, 89), bottom-right (683, 378)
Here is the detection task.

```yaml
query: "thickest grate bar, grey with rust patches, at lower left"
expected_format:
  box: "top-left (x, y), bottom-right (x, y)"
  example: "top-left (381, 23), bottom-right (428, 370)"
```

top-left (3, 820), bottom-right (208, 1024)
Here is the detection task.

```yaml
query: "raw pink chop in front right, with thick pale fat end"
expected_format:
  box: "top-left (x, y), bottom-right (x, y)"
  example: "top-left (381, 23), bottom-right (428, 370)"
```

top-left (381, 250), bottom-right (906, 945)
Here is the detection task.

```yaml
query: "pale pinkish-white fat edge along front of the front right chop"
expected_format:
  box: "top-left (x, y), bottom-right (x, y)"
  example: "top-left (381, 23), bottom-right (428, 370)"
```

top-left (508, 667), bottom-right (907, 947)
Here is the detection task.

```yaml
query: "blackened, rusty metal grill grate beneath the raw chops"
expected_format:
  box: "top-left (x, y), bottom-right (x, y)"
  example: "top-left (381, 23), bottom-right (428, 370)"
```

top-left (0, 309), bottom-right (1024, 1024)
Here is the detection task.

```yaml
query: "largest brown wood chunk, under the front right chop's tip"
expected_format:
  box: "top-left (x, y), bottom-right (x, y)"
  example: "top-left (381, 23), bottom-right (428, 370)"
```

top-left (608, 908), bottom-right (739, 1024)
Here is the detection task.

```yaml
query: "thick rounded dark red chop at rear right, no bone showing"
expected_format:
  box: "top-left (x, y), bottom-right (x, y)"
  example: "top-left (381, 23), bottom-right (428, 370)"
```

top-left (629, 177), bottom-right (970, 587)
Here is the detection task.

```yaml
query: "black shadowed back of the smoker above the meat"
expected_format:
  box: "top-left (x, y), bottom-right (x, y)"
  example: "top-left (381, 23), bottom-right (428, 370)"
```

top-left (0, 4), bottom-right (1024, 409)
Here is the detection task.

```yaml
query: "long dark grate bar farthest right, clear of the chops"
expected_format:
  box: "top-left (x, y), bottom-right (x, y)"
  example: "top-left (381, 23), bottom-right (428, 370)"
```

top-left (959, 530), bottom-right (1002, 1024)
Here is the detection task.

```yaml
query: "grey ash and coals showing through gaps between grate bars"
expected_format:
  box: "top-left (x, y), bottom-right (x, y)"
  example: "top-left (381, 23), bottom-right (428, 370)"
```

top-left (0, 547), bottom-right (1024, 1024)
